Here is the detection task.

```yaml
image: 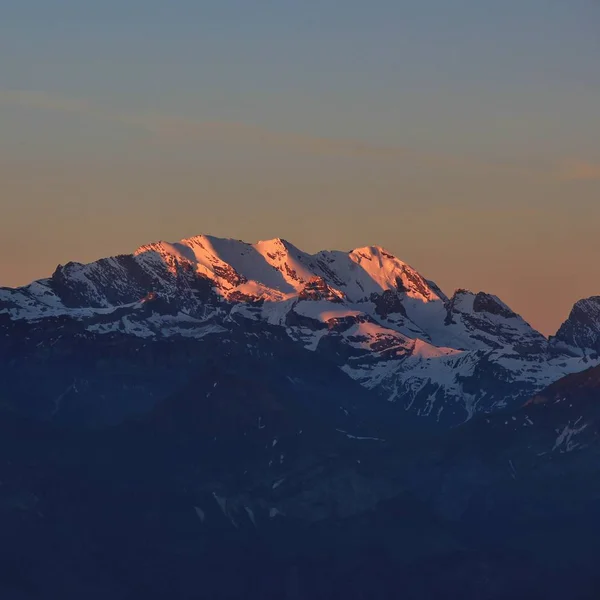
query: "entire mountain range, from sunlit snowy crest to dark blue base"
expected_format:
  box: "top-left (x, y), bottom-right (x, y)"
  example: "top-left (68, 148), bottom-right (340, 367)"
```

top-left (0, 236), bottom-right (600, 600)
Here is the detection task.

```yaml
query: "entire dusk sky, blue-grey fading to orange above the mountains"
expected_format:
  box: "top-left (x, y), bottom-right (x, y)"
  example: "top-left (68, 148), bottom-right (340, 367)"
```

top-left (0, 0), bottom-right (600, 334)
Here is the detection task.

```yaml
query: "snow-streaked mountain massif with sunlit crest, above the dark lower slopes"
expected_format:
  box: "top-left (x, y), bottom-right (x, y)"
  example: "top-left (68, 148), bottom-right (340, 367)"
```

top-left (0, 236), bottom-right (597, 426)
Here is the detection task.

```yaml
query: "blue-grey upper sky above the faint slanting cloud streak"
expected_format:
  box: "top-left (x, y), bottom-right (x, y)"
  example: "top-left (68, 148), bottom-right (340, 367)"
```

top-left (0, 0), bottom-right (600, 159)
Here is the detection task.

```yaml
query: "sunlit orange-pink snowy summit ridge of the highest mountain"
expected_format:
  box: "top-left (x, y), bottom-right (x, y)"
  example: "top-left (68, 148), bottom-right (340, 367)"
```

top-left (134, 235), bottom-right (446, 302)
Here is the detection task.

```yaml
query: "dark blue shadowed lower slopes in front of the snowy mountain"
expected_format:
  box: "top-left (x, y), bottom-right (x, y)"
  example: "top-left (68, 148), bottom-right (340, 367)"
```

top-left (0, 355), bottom-right (600, 600)
